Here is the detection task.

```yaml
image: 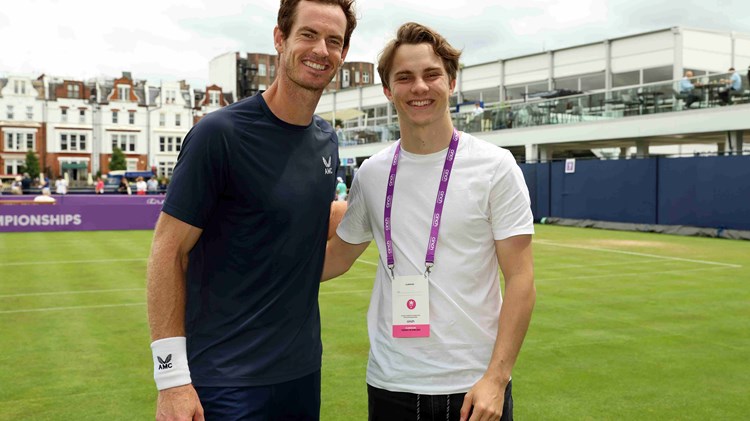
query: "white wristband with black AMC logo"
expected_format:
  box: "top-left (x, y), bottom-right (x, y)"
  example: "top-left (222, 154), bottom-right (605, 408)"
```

top-left (151, 336), bottom-right (192, 390)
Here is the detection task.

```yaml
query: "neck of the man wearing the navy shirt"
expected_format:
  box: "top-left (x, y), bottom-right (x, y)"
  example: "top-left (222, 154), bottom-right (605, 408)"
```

top-left (262, 75), bottom-right (323, 126)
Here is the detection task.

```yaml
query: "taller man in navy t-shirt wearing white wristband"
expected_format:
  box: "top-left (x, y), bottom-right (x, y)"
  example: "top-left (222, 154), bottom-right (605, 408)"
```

top-left (148, 0), bottom-right (356, 420)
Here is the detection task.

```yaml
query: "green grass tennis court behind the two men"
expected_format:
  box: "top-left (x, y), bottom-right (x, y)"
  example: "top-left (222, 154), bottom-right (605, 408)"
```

top-left (0, 225), bottom-right (750, 421)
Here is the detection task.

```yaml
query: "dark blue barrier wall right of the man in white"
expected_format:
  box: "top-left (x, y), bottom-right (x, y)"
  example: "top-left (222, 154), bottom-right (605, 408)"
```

top-left (521, 156), bottom-right (750, 230)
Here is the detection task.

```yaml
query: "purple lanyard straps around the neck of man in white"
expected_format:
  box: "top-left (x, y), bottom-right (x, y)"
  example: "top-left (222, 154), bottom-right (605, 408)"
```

top-left (383, 129), bottom-right (458, 276)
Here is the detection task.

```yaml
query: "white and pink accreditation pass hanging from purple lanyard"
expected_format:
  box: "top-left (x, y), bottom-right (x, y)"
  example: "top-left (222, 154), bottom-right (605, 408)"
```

top-left (391, 275), bottom-right (430, 338)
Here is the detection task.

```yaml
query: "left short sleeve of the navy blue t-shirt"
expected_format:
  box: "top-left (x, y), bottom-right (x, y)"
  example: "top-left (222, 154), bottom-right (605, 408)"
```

top-left (162, 116), bottom-right (230, 228)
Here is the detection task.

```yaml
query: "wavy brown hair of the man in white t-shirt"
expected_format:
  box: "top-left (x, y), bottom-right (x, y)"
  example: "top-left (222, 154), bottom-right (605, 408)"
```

top-left (378, 22), bottom-right (461, 89)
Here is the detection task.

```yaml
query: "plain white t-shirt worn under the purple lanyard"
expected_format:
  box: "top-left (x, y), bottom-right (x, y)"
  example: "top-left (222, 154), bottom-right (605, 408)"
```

top-left (336, 133), bottom-right (534, 394)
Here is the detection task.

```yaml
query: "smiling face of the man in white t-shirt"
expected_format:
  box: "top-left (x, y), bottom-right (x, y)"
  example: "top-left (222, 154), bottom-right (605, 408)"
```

top-left (383, 43), bottom-right (456, 127)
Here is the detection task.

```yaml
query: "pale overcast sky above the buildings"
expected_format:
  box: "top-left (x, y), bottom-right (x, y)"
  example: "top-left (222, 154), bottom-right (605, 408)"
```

top-left (0, 0), bottom-right (750, 86)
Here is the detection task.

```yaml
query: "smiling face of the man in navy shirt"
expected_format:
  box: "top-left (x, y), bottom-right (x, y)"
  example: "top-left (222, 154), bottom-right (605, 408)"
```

top-left (274, 1), bottom-right (347, 92)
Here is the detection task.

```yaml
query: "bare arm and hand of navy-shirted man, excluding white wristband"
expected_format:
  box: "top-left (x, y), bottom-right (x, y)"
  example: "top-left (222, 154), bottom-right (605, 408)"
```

top-left (147, 212), bottom-right (203, 420)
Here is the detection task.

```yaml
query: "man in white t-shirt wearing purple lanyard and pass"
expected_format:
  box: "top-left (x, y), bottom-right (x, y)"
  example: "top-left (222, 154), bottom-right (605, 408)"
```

top-left (322, 23), bottom-right (536, 421)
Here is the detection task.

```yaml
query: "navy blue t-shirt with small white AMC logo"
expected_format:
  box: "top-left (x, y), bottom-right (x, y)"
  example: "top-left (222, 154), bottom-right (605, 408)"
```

top-left (162, 95), bottom-right (339, 387)
